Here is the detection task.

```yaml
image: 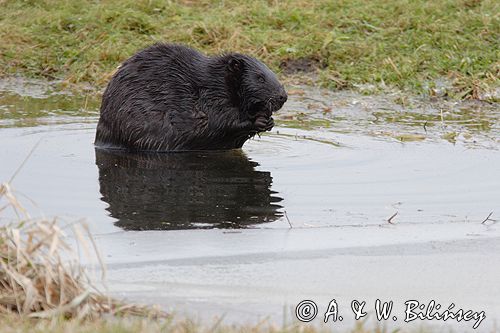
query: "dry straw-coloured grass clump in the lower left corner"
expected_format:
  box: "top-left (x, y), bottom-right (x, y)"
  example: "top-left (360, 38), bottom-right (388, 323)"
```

top-left (0, 183), bottom-right (165, 319)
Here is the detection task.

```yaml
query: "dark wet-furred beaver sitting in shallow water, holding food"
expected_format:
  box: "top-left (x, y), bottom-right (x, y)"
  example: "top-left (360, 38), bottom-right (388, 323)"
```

top-left (95, 43), bottom-right (288, 152)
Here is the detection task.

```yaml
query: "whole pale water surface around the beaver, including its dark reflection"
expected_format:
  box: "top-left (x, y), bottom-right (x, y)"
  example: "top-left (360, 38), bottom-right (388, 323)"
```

top-left (0, 80), bottom-right (500, 329)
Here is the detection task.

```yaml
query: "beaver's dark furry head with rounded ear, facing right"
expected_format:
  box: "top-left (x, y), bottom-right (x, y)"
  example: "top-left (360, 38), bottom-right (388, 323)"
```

top-left (226, 54), bottom-right (288, 118)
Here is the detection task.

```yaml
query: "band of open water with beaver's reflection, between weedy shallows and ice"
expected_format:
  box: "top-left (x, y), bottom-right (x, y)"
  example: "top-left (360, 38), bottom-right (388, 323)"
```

top-left (0, 124), bottom-right (500, 232)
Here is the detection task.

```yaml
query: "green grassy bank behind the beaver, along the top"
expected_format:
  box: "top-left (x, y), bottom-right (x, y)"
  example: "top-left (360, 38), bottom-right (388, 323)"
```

top-left (0, 0), bottom-right (500, 98)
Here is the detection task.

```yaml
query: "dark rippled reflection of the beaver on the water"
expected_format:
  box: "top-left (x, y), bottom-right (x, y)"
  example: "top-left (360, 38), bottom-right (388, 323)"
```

top-left (96, 149), bottom-right (282, 230)
